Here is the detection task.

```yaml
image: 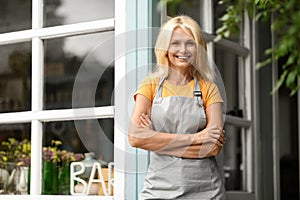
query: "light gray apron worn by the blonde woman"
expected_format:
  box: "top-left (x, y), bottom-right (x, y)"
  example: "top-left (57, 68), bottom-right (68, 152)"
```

top-left (139, 78), bottom-right (225, 200)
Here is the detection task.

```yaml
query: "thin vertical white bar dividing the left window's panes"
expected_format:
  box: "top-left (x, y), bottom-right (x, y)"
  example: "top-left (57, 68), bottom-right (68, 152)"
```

top-left (30, 0), bottom-right (44, 195)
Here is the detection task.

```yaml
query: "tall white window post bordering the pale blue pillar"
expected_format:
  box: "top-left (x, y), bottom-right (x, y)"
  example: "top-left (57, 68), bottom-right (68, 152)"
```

top-left (114, 0), bottom-right (127, 199)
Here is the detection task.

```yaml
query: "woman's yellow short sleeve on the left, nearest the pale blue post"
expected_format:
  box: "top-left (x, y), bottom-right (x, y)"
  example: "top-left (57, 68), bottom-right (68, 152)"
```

top-left (133, 77), bottom-right (158, 102)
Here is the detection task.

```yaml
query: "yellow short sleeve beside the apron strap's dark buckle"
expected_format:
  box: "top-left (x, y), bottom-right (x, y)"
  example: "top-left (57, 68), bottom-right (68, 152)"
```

top-left (200, 79), bottom-right (224, 108)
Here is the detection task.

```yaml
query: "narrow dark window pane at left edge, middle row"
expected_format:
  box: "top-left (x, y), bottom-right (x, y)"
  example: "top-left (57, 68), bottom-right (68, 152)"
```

top-left (0, 42), bottom-right (31, 113)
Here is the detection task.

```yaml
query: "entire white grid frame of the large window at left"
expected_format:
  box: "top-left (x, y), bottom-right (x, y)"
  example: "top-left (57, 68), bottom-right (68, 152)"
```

top-left (0, 0), bottom-right (127, 200)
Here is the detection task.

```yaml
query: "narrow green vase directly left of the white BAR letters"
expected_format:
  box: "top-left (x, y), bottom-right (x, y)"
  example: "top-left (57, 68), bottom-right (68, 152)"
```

top-left (58, 163), bottom-right (70, 195)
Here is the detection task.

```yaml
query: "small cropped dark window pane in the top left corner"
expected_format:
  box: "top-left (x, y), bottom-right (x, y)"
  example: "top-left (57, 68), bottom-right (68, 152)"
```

top-left (0, 0), bottom-right (31, 33)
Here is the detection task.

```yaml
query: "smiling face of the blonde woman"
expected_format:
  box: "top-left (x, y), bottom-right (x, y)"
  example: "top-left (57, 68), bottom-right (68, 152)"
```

top-left (167, 27), bottom-right (196, 71)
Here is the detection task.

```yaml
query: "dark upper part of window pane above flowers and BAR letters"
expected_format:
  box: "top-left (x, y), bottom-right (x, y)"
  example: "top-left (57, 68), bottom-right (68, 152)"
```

top-left (43, 119), bottom-right (114, 163)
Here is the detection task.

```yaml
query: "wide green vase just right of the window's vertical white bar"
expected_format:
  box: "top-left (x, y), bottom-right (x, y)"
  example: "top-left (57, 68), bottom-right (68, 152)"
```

top-left (42, 161), bottom-right (58, 195)
